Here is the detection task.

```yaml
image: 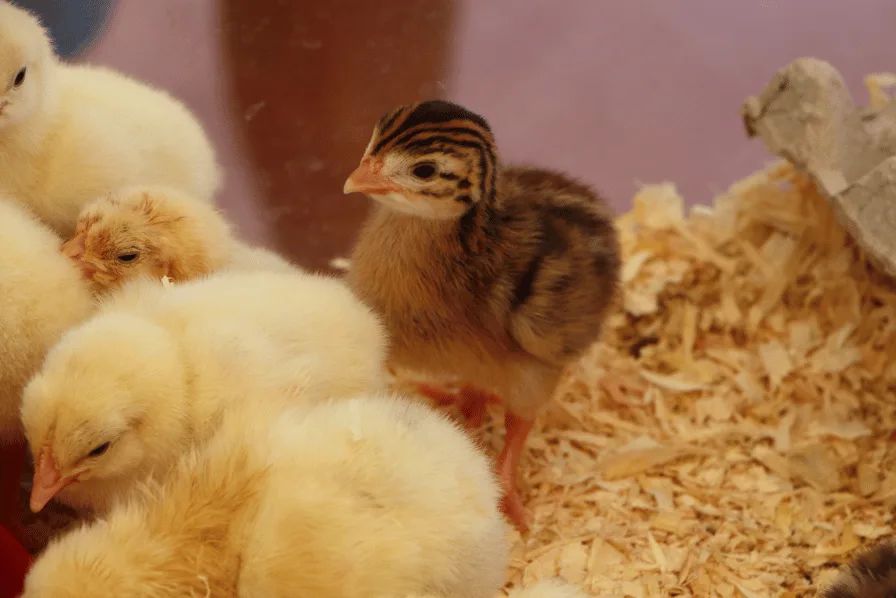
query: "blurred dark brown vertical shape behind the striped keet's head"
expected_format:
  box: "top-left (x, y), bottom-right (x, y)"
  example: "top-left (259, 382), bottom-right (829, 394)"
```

top-left (222, 0), bottom-right (452, 269)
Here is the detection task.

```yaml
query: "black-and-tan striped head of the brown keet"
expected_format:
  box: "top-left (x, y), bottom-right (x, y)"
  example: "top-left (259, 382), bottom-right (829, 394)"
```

top-left (343, 100), bottom-right (498, 219)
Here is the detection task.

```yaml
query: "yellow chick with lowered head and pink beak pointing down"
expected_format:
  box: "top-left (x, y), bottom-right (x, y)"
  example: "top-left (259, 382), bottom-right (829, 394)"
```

top-left (22, 272), bottom-right (386, 511)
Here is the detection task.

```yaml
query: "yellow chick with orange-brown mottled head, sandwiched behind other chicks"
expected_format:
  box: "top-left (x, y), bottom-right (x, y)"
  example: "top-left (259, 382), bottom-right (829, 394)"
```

top-left (62, 186), bottom-right (295, 289)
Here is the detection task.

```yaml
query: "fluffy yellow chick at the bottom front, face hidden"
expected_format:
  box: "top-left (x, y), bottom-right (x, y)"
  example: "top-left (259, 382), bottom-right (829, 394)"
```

top-left (23, 394), bottom-right (508, 598)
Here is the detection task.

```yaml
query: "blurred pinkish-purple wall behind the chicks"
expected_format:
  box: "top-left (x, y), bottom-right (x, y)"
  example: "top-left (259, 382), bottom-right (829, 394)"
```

top-left (85, 0), bottom-right (896, 248)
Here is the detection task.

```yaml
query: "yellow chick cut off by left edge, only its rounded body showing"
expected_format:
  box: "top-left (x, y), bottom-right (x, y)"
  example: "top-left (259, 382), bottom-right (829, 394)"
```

top-left (0, 197), bottom-right (94, 527)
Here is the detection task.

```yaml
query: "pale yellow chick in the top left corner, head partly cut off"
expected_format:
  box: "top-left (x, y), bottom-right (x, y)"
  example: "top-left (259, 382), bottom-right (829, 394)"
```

top-left (0, 0), bottom-right (221, 237)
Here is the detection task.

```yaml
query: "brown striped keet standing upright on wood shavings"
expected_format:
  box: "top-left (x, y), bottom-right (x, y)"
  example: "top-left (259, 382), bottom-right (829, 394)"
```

top-left (344, 101), bottom-right (620, 530)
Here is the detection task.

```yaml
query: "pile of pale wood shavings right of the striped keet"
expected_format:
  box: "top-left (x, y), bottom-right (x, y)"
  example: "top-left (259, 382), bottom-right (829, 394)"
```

top-left (442, 164), bottom-right (896, 598)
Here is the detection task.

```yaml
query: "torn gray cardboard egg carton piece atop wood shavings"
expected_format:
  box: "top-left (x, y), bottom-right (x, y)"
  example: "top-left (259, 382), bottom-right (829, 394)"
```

top-left (742, 58), bottom-right (896, 278)
